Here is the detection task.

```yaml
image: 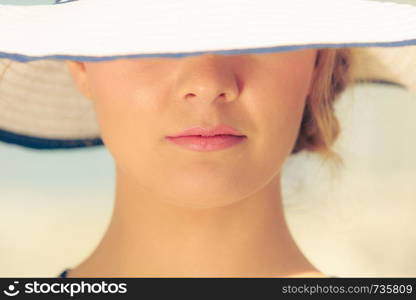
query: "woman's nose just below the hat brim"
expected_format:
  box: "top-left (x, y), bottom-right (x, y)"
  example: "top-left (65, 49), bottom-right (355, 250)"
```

top-left (175, 54), bottom-right (239, 105)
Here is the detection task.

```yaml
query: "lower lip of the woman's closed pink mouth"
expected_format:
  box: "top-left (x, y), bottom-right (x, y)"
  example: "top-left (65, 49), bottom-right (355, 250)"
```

top-left (166, 135), bottom-right (246, 152)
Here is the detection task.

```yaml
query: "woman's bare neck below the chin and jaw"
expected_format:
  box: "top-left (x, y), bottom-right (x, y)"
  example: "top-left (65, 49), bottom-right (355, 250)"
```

top-left (69, 166), bottom-right (320, 277)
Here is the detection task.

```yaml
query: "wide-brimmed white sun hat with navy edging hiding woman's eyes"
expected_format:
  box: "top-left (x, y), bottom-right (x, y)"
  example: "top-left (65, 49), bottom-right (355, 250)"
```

top-left (0, 0), bottom-right (416, 149)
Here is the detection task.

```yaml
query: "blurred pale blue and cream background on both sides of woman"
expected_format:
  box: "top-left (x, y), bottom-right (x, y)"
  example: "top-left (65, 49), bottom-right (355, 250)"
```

top-left (0, 0), bottom-right (416, 277)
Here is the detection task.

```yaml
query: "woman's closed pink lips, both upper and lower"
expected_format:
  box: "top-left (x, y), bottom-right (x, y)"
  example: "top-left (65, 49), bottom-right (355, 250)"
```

top-left (166, 125), bottom-right (246, 151)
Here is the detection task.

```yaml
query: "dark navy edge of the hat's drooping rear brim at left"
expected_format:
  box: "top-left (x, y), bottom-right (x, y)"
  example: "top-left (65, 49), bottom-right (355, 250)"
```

top-left (0, 129), bottom-right (104, 150)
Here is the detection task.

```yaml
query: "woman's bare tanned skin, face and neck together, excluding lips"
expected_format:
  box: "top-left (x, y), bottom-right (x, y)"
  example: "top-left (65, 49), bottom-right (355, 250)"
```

top-left (66, 49), bottom-right (326, 277)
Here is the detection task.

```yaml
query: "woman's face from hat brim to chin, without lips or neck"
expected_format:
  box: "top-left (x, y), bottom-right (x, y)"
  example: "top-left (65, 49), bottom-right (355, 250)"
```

top-left (69, 49), bottom-right (317, 207)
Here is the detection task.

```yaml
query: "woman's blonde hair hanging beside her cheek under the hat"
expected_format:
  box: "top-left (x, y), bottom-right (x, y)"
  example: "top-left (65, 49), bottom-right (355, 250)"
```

top-left (292, 48), bottom-right (352, 168)
